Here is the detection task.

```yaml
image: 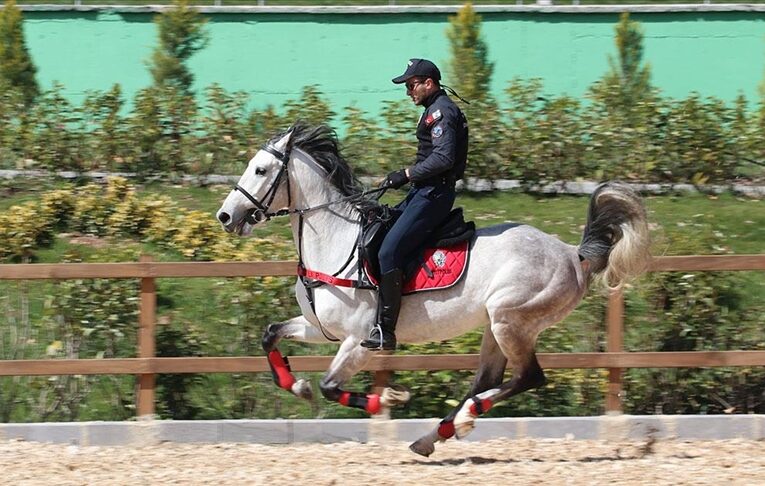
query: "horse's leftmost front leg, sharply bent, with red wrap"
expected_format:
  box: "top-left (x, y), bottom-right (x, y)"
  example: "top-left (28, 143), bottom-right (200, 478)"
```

top-left (262, 316), bottom-right (336, 400)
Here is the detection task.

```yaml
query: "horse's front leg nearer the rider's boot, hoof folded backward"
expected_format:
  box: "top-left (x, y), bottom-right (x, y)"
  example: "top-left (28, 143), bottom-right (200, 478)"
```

top-left (319, 336), bottom-right (409, 415)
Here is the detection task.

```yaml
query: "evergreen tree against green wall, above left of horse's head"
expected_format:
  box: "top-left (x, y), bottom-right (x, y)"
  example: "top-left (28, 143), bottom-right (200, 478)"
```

top-left (149, 0), bottom-right (209, 94)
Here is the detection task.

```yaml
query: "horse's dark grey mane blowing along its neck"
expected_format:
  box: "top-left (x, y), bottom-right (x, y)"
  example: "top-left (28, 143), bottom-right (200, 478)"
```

top-left (271, 120), bottom-right (372, 208)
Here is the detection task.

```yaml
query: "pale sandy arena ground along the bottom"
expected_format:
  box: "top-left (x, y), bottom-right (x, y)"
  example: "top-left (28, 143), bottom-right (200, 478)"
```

top-left (0, 439), bottom-right (765, 486)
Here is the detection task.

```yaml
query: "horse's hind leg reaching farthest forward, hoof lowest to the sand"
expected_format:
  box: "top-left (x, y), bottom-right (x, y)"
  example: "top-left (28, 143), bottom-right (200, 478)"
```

top-left (409, 326), bottom-right (507, 457)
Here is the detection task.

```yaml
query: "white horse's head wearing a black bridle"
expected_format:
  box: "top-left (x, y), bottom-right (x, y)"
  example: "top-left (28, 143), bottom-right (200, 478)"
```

top-left (216, 129), bottom-right (293, 235)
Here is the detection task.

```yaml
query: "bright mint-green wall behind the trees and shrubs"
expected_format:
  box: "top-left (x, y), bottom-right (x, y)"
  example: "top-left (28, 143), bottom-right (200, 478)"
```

top-left (24, 11), bottom-right (765, 113)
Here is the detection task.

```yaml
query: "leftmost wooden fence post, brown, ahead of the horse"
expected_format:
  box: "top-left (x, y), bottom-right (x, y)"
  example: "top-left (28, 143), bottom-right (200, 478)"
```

top-left (136, 255), bottom-right (157, 417)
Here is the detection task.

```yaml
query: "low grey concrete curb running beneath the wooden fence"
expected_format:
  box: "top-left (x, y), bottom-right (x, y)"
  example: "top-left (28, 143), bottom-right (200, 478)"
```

top-left (0, 415), bottom-right (765, 447)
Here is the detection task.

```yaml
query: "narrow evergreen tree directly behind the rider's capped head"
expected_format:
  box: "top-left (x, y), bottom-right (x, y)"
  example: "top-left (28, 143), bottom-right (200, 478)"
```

top-left (446, 2), bottom-right (494, 100)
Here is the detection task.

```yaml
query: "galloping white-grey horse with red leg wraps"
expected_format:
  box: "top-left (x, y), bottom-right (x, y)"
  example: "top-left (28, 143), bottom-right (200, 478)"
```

top-left (216, 122), bottom-right (649, 456)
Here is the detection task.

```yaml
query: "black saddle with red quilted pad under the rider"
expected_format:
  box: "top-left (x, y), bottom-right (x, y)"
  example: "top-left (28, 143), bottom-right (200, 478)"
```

top-left (358, 205), bottom-right (475, 294)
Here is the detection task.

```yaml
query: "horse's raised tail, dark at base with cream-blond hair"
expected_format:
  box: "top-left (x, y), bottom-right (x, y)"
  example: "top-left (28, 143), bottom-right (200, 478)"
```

top-left (579, 182), bottom-right (650, 289)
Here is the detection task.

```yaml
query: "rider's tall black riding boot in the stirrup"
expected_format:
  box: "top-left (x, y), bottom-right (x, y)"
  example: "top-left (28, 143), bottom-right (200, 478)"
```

top-left (361, 269), bottom-right (403, 351)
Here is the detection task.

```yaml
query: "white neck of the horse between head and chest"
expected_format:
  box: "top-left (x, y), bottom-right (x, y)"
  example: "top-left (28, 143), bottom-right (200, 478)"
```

top-left (290, 152), bottom-right (359, 273)
